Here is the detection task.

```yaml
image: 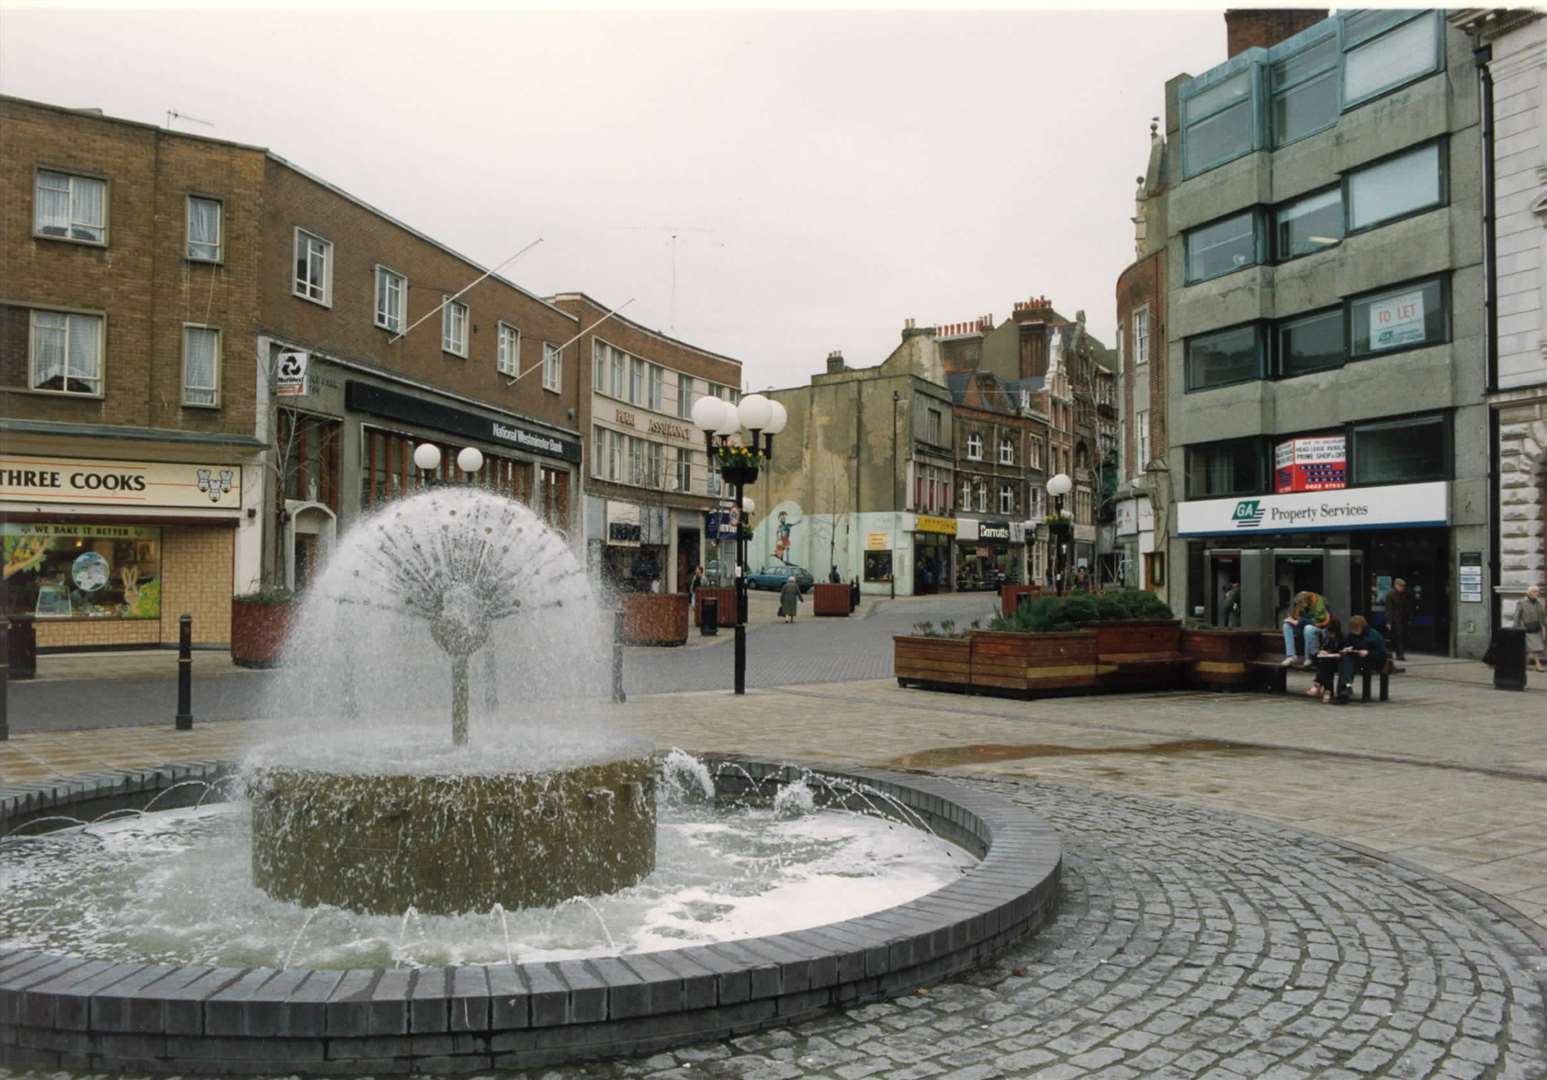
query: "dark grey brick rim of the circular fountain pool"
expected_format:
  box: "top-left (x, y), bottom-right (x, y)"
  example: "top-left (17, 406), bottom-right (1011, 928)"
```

top-left (0, 760), bottom-right (1061, 1074)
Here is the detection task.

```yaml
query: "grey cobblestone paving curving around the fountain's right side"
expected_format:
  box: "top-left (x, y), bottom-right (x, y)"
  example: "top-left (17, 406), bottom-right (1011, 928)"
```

top-left (9, 780), bottom-right (1547, 1080)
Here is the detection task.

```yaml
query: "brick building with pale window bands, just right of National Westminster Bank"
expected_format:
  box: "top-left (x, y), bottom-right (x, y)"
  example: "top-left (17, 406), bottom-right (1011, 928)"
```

top-left (552, 292), bottom-right (741, 593)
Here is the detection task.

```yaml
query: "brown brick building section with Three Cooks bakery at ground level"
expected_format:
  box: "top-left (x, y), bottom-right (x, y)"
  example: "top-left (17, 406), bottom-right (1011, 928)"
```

top-left (0, 97), bottom-right (265, 648)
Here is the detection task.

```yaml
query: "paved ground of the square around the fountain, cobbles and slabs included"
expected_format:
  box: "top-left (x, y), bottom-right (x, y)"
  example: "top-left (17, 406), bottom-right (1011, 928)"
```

top-left (0, 594), bottom-right (1547, 1080)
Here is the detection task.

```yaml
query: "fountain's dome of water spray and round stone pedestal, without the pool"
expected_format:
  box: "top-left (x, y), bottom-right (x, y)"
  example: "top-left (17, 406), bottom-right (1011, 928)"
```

top-left (249, 487), bottom-right (656, 914)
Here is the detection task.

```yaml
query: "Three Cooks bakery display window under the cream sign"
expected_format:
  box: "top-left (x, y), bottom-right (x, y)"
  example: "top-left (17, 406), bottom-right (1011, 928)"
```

top-left (0, 521), bottom-right (161, 619)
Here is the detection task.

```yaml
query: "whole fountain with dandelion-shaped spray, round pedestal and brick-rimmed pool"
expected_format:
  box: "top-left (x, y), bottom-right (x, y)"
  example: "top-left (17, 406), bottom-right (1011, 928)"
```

top-left (0, 487), bottom-right (1061, 1074)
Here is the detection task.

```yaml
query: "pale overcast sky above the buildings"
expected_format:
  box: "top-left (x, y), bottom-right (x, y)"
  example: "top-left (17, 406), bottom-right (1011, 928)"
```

top-left (0, 8), bottom-right (1225, 388)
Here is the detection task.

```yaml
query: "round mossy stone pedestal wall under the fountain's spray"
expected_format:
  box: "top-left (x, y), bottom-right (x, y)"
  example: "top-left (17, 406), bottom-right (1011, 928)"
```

top-left (249, 757), bottom-right (656, 914)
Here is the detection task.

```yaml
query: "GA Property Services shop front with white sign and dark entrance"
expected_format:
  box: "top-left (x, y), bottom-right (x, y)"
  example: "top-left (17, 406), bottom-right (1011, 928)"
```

top-left (1177, 481), bottom-right (1454, 654)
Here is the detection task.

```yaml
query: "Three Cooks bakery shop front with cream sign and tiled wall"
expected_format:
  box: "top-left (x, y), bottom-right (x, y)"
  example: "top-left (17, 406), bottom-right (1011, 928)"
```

top-left (0, 453), bottom-right (258, 650)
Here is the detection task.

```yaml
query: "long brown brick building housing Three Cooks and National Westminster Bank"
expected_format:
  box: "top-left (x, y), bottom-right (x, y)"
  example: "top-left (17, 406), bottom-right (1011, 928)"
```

top-left (0, 97), bottom-right (582, 648)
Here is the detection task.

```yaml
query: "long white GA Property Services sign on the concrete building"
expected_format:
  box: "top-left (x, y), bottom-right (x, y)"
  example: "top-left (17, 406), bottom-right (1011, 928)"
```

top-left (1177, 480), bottom-right (1450, 537)
